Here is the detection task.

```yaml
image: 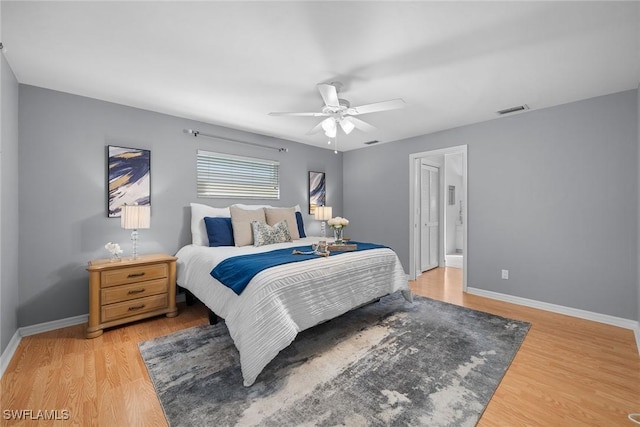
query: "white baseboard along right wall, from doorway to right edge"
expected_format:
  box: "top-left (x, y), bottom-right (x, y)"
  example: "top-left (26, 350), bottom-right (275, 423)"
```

top-left (467, 286), bottom-right (640, 354)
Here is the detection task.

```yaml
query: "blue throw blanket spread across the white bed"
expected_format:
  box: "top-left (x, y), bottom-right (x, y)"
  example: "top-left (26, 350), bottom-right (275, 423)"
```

top-left (211, 242), bottom-right (386, 295)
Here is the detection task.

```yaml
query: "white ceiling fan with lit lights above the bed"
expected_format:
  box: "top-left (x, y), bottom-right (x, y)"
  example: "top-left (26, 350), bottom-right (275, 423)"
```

top-left (269, 82), bottom-right (406, 138)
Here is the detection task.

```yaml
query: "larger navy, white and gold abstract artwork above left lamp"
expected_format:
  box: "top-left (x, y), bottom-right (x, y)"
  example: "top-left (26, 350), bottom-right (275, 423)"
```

top-left (107, 145), bottom-right (151, 217)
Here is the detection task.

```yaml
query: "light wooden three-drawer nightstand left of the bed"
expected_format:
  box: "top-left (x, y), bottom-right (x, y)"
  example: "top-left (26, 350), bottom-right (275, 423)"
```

top-left (87, 254), bottom-right (178, 338)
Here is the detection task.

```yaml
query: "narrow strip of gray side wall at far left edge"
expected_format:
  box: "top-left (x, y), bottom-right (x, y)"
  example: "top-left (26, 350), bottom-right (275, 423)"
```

top-left (0, 53), bottom-right (19, 353)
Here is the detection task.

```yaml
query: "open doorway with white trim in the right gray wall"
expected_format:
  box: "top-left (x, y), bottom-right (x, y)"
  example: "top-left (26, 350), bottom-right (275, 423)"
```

top-left (409, 145), bottom-right (469, 291)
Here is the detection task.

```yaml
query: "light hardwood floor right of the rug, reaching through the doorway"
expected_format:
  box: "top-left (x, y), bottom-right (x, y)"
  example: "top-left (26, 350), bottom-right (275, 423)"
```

top-left (411, 268), bottom-right (640, 426)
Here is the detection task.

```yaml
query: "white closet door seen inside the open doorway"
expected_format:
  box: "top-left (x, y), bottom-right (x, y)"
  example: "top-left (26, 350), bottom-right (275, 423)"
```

top-left (420, 165), bottom-right (440, 271)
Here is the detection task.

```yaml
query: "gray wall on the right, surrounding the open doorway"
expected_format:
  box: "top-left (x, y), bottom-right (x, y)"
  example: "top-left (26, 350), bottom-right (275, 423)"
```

top-left (344, 90), bottom-right (639, 319)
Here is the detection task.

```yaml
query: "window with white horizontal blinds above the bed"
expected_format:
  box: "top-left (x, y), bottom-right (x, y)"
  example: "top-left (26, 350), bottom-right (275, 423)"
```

top-left (197, 150), bottom-right (280, 199)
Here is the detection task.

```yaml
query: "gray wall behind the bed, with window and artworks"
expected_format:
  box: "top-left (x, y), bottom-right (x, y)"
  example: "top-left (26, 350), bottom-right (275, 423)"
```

top-left (18, 85), bottom-right (342, 326)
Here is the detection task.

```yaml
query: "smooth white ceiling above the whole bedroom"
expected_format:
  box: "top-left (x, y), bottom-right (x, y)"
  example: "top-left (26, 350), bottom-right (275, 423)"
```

top-left (1, 0), bottom-right (640, 151)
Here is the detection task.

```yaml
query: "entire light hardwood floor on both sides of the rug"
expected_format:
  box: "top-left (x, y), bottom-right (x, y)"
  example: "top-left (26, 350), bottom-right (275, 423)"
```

top-left (0, 268), bottom-right (640, 427)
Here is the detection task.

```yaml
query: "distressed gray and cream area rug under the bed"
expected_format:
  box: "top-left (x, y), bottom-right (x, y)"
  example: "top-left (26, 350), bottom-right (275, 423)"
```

top-left (139, 293), bottom-right (530, 427)
